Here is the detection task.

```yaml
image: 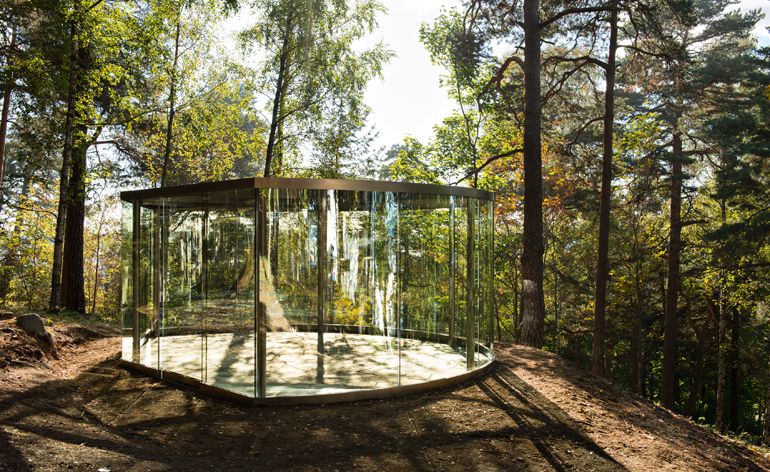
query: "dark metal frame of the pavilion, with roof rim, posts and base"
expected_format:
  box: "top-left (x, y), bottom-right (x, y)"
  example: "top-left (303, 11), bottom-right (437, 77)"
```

top-left (120, 177), bottom-right (494, 405)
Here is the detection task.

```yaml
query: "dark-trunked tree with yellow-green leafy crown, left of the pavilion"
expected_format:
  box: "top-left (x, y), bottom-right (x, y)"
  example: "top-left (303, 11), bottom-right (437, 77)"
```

top-left (36, 0), bottom-right (181, 312)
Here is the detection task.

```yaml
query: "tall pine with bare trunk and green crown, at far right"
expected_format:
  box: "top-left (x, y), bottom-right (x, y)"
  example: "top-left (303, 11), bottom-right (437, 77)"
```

top-left (624, 0), bottom-right (758, 408)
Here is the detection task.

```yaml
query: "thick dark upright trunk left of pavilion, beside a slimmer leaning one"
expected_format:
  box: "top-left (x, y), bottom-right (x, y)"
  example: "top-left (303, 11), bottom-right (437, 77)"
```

top-left (61, 127), bottom-right (88, 314)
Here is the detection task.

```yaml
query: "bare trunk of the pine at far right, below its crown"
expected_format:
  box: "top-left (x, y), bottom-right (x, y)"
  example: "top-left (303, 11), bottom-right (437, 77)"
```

top-left (661, 120), bottom-right (683, 410)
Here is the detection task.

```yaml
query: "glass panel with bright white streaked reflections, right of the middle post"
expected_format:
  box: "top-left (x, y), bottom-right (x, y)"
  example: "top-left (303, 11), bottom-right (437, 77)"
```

top-left (321, 191), bottom-right (399, 392)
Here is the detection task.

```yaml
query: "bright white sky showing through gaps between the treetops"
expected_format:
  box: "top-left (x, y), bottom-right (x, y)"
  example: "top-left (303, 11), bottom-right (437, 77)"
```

top-left (220, 0), bottom-right (770, 156)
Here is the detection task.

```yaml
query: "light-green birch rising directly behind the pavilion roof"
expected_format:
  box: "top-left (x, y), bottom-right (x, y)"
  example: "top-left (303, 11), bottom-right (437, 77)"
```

top-left (241, 0), bottom-right (390, 177)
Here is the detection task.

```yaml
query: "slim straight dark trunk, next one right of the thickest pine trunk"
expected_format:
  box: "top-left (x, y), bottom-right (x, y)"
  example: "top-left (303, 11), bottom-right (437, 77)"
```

top-left (592, 5), bottom-right (618, 376)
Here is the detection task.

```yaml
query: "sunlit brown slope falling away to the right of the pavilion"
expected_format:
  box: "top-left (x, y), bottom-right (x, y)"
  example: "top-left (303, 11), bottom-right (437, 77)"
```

top-left (496, 345), bottom-right (770, 471)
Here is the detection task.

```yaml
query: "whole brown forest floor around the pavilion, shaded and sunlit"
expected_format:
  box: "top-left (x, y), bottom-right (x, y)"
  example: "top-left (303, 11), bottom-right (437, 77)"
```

top-left (0, 321), bottom-right (770, 471)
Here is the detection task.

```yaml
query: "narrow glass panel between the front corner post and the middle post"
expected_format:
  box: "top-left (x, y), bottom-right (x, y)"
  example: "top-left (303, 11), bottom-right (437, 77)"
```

top-left (259, 189), bottom-right (316, 396)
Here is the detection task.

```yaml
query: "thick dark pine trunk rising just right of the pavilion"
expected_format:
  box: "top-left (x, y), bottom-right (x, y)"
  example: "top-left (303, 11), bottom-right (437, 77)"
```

top-left (521, 0), bottom-right (545, 348)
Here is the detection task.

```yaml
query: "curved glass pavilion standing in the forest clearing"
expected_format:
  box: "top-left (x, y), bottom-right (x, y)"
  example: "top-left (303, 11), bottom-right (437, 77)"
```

top-left (121, 178), bottom-right (494, 403)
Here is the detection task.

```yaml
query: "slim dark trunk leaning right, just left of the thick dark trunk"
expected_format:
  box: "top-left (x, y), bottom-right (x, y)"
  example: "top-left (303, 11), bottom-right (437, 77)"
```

top-left (48, 19), bottom-right (79, 310)
